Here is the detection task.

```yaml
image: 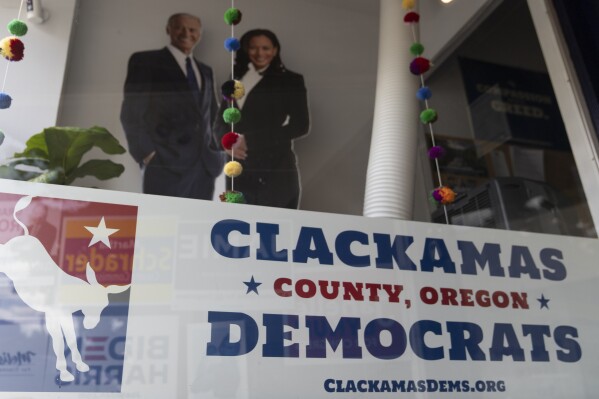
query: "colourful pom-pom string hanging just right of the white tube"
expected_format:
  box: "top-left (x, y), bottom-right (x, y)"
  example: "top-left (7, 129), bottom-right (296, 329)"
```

top-left (402, 0), bottom-right (456, 224)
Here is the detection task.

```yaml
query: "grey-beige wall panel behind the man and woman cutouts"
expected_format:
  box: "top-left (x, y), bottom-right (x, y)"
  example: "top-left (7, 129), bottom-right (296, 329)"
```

top-left (60, 0), bottom-right (378, 214)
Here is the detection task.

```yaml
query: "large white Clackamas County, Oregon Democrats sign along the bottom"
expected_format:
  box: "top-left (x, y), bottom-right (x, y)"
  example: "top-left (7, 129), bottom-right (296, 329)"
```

top-left (0, 180), bottom-right (599, 399)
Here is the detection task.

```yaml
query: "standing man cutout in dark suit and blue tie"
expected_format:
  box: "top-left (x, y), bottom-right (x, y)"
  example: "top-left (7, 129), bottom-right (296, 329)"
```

top-left (121, 13), bottom-right (224, 200)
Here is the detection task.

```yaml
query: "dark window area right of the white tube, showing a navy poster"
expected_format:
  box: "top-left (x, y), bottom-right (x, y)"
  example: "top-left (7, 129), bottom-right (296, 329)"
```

top-left (422, 0), bottom-right (596, 237)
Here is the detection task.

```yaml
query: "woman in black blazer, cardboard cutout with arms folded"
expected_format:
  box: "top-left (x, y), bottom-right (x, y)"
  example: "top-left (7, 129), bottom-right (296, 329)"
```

top-left (214, 29), bottom-right (310, 209)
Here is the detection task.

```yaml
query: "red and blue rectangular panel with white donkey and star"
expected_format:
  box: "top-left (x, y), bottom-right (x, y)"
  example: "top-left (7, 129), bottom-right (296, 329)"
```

top-left (0, 193), bottom-right (137, 392)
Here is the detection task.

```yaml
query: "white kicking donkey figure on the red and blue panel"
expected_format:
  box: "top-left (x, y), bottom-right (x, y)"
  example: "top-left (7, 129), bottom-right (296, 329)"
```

top-left (0, 197), bottom-right (129, 382)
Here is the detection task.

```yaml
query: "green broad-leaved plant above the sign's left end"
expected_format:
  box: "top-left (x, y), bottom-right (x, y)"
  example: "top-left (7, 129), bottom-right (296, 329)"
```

top-left (0, 126), bottom-right (126, 185)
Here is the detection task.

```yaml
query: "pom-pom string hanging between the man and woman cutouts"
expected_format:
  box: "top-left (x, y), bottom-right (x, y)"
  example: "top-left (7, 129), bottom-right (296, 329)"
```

top-left (220, 0), bottom-right (245, 203)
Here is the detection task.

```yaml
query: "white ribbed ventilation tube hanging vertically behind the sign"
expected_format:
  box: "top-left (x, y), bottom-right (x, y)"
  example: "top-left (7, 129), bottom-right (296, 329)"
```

top-left (364, 0), bottom-right (420, 220)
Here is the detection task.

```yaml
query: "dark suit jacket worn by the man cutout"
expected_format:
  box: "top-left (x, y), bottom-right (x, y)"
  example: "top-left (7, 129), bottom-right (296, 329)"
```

top-left (121, 47), bottom-right (223, 199)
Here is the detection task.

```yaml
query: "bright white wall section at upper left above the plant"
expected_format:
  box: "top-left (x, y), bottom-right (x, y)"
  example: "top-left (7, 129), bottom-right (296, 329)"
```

top-left (0, 0), bottom-right (76, 159)
